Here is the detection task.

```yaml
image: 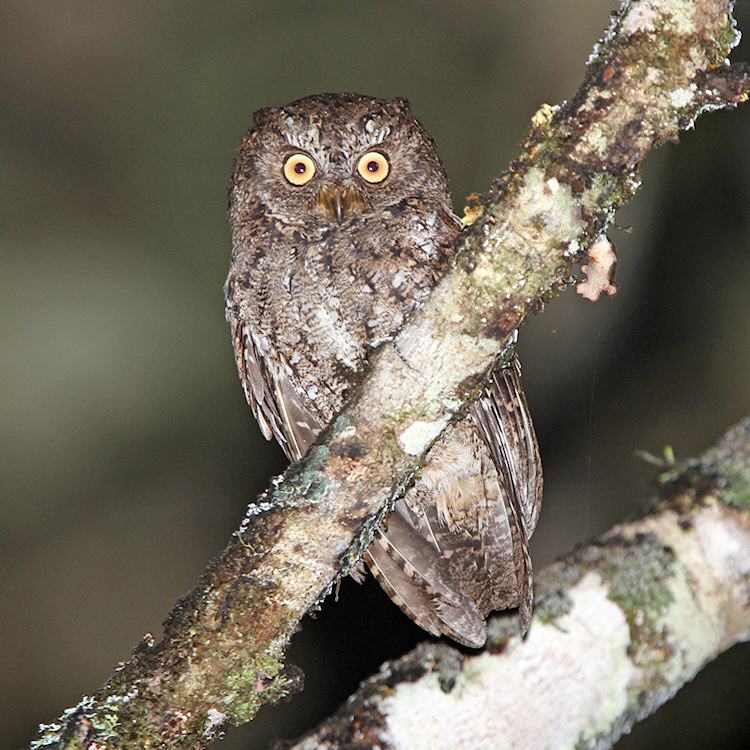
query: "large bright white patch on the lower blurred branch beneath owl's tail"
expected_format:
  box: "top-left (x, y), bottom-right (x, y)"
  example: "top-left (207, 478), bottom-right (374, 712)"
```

top-left (383, 573), bottom-right (637, 750)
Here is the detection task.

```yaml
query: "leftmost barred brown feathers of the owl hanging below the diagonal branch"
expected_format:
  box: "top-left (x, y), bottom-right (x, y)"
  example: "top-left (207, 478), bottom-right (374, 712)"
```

top-left (365, 501), bottom-right (487, 648)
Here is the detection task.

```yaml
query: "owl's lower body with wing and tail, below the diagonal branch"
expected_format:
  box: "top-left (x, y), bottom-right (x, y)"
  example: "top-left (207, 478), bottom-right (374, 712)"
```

top-left (365, 360), bottom-right (542, 647)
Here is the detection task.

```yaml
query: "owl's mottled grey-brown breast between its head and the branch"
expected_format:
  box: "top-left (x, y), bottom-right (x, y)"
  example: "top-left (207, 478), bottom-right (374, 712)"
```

top-left (227, 204), bottom-right (457, 421)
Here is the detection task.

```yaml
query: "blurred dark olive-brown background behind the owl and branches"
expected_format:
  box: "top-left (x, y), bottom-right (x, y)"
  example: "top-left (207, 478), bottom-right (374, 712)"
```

top-left (0, 0), bottom-right (750, 749)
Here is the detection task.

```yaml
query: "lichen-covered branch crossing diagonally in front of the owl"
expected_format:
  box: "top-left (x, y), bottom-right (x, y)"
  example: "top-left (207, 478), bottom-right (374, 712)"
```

top-left (29, 0), bottom-right (750, 750)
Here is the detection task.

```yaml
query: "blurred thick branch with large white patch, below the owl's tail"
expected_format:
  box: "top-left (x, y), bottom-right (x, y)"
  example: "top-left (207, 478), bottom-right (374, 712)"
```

top-left (290, 418), bottom-right (750, 750)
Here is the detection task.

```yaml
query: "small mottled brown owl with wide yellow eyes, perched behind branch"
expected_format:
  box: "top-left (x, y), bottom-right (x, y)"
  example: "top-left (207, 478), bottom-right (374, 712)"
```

top-left (225, 94), bottom-right (542, 647)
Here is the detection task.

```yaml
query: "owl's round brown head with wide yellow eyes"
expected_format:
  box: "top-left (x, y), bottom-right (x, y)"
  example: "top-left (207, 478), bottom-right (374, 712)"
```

top-left (229, 94), bottom-right (451, 227)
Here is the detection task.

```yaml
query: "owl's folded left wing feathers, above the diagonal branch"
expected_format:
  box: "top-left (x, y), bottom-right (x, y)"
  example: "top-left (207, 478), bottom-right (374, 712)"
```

top-left (227, 314), bottom-right (321, 461)
